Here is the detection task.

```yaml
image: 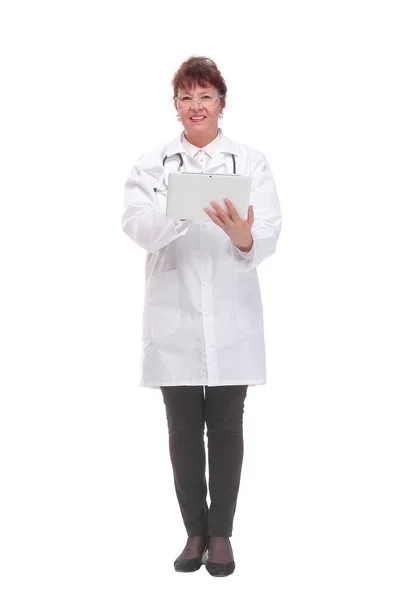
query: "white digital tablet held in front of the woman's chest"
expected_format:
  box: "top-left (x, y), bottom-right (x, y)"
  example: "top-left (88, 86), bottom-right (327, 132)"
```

top-left (166, 171), bottom-right (252, 221)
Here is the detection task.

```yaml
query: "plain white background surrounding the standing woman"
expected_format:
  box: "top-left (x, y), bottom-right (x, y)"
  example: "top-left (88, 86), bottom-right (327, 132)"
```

top-left (0, 0), bottom-right (400, 600)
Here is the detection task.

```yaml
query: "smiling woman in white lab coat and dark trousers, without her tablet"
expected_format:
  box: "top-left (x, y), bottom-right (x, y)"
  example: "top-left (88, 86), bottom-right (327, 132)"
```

top-left (122, 57), bottom-right (281, 576)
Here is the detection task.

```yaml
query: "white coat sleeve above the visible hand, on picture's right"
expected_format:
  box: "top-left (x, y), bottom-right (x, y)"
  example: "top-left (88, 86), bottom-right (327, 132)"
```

top-left (231, 153), bottom-right (282, 271)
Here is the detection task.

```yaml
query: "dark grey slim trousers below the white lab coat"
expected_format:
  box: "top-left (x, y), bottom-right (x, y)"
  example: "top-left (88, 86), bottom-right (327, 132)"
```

top-left (161, 385), bottom-right (248, 537)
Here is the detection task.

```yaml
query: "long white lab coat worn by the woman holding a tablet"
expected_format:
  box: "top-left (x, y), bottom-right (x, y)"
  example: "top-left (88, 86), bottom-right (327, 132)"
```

top-left (122, 130), bottom-right (281, 389)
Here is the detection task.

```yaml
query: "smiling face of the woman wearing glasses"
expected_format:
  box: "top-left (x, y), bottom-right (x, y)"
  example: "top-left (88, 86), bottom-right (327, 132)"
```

top-left (175, 84), bottom-right (223, 139)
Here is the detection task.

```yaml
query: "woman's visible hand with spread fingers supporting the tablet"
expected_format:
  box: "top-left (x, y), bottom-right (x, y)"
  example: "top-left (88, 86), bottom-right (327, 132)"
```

top-left (204, 200), bottom-right (254, 249)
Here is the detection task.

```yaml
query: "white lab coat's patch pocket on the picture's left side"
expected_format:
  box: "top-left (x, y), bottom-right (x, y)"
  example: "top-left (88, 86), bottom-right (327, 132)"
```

top-left (143, 269), bottom-right (180, 339)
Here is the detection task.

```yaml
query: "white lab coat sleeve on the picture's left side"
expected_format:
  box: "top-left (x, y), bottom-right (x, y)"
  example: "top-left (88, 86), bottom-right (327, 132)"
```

top-left (121, 163), bottom-right (191, 253)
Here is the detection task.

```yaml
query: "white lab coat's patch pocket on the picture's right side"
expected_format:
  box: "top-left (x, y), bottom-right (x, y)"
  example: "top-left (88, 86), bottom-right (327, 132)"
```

top-left (235, 270), bottom-right (264, 335)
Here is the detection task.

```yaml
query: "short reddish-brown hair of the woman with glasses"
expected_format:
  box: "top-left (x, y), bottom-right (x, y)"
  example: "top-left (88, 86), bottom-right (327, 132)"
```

top-left (171, 56), bottom-right (228, 108)
